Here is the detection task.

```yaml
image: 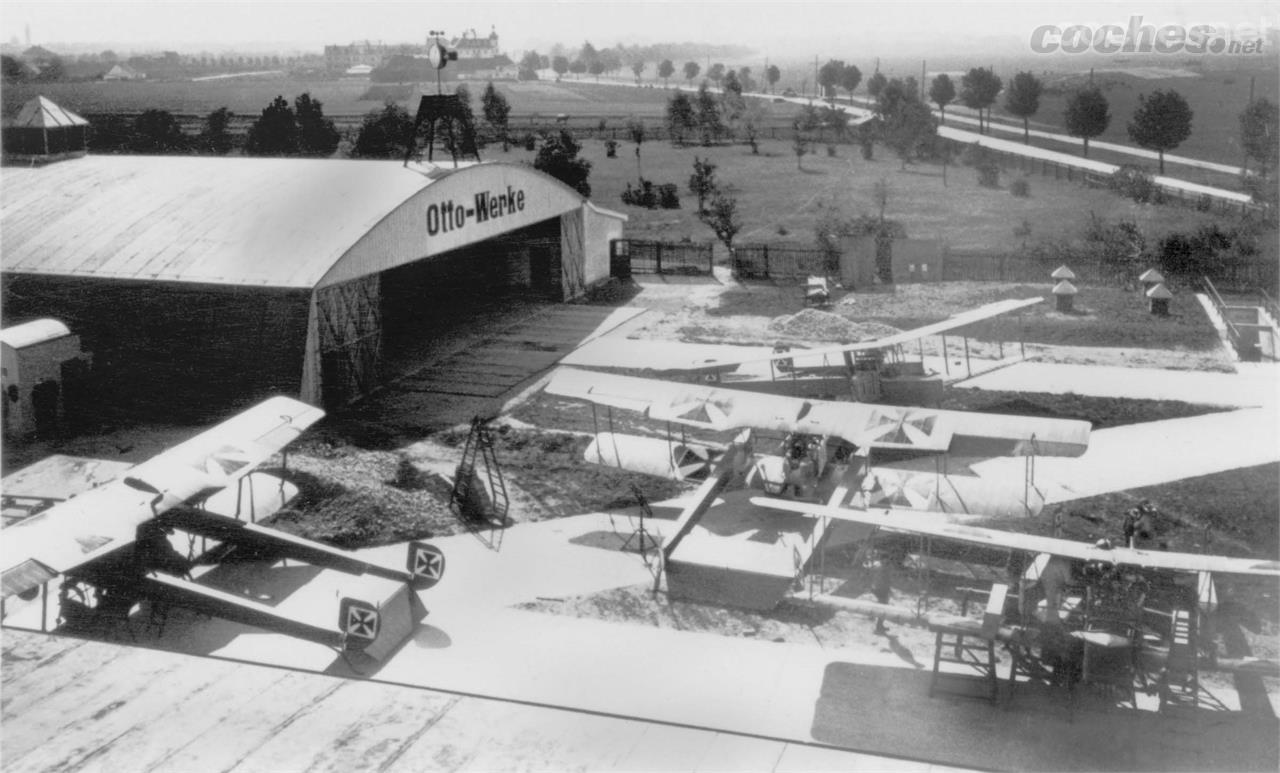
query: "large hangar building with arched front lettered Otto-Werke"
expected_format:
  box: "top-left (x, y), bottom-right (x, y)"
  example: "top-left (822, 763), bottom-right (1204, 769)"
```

top-left (0, 156), bottom-right (625, 408)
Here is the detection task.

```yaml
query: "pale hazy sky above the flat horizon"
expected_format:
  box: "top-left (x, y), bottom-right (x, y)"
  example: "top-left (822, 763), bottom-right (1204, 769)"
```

top-left (0, 0), bottom-right (1280, 58)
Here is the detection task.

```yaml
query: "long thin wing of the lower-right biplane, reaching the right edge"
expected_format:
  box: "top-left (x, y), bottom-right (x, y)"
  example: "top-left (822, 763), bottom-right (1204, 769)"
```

top-left (751, 497), bottom-right (1280, 577)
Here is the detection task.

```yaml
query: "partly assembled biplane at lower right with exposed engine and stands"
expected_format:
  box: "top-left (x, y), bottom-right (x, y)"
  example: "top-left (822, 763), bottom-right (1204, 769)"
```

top-left (751, 497), bottom-right (1280, 717)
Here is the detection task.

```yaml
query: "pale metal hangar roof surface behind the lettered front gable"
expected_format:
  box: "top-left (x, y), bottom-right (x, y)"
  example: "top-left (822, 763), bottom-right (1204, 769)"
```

top-left (0, 156), bottom-right (431, 288)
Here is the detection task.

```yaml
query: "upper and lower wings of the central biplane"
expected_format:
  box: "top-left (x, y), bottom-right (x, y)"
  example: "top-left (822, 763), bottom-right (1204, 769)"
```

top-left (547, 369), bottom-right (1089, 517)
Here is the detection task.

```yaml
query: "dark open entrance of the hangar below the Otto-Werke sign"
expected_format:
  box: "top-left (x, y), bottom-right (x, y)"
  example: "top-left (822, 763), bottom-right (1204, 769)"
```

top-left (381, 218), bottom-right (564, 379)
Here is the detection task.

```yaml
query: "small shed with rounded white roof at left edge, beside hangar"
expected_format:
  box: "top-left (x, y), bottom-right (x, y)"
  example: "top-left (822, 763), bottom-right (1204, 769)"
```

top-left (0, 319), bottom-right (88, 439)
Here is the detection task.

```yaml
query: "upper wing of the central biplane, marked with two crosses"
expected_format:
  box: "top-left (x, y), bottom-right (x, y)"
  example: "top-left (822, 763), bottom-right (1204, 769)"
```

top-left (547, 369), bottom-right (1089, 456)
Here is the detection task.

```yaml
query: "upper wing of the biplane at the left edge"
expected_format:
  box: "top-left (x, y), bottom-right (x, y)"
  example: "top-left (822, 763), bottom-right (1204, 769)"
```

top-left (0, 397), bottom-right (324, 598)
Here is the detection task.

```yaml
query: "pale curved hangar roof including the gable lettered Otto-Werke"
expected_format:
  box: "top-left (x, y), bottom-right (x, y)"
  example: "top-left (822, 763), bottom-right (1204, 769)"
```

top-left (0, 156), bottom-right (584, 288)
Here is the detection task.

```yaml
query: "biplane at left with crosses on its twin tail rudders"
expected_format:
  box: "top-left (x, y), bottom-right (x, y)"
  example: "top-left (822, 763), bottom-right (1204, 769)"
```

top-left (0, 397), bottom-right (444, 659)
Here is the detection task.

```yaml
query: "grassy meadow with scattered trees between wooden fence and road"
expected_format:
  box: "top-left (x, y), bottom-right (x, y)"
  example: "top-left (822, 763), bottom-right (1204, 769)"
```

top-left (484, 126), bottom-right (1249, 253)
